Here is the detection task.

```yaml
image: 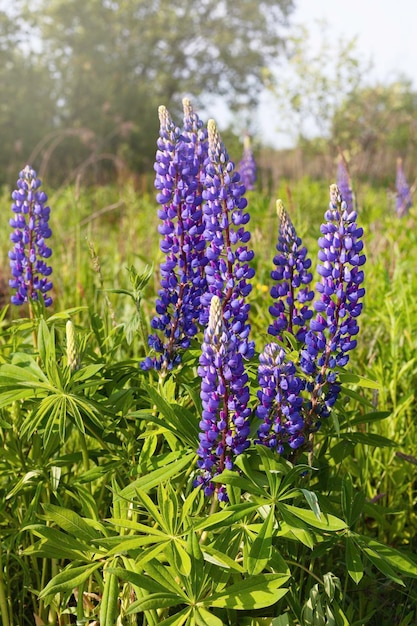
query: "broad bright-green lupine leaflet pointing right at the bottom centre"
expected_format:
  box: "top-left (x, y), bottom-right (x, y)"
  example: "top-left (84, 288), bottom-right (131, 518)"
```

top-left (199, 574), bottom-right (289, 611)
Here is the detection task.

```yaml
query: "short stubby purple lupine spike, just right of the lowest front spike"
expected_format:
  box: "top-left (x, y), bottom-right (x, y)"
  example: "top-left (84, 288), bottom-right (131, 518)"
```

top-left (256, 342), bottom-right (305, 454)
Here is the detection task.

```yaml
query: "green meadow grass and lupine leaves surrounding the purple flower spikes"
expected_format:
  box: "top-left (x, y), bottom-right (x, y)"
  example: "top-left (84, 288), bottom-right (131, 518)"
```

top-left (0, 172), bottom-right (417, 626)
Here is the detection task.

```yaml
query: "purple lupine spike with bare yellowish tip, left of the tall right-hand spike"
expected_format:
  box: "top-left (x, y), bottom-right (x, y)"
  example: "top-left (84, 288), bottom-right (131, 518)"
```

top-left (268, 200), bottom-right (314, 342)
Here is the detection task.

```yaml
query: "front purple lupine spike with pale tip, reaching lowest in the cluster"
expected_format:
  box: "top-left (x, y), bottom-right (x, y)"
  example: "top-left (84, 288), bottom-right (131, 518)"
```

top-left (195, 295), bottom-right (250, 501)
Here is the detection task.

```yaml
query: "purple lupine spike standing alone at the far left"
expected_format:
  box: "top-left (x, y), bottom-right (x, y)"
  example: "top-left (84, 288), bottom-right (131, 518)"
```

top-left (9, 165), bottom-right (52, 306)
